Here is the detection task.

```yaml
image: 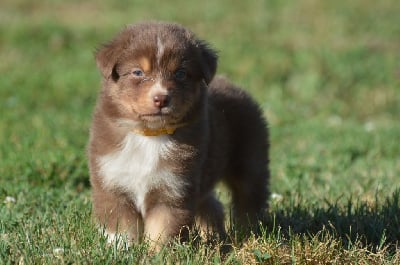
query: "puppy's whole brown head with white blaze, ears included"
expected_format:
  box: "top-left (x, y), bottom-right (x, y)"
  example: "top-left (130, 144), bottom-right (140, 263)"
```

top-left (96, 23), bottom-right (217, 128)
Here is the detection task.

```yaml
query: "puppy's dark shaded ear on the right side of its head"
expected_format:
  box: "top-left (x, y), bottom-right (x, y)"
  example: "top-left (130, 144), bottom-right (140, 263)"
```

top-left (197, 40), bottom-right (218, 84)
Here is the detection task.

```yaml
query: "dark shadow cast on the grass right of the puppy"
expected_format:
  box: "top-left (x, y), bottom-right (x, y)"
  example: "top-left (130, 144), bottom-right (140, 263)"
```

top-left (264, 190), bottom-right (400, 251)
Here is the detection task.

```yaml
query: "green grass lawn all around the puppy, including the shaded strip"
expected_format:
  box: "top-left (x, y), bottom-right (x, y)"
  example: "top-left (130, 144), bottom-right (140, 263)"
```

top-left (0, 0), bottom-right (400, 264)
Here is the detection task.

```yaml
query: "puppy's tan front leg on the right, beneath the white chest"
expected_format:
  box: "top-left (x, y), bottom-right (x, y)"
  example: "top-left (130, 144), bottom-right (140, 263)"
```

top-left (144, 204), bottom-right (194, 246)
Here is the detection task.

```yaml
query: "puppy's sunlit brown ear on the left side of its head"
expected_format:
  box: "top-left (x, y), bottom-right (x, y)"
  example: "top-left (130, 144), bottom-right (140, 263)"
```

top-left (95, 40), bottom-right (122, 81)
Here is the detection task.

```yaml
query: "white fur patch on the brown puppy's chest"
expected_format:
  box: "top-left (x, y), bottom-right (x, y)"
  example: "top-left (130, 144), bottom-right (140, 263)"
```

top-left (98, 133), bottom-right (183, 214)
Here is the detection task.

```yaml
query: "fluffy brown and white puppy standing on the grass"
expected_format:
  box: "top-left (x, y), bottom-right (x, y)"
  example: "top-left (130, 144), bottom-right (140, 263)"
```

top-left (88, 22), bottom-right (269, 246)
